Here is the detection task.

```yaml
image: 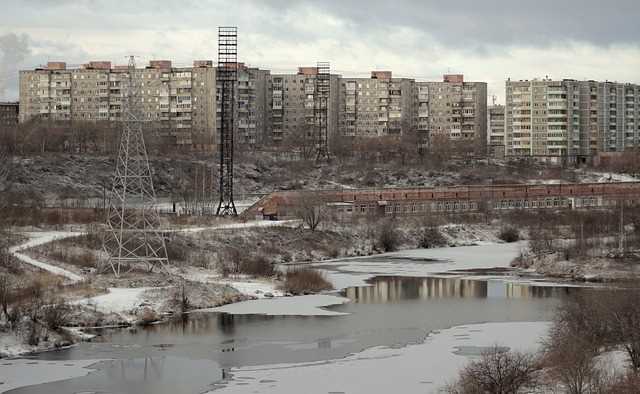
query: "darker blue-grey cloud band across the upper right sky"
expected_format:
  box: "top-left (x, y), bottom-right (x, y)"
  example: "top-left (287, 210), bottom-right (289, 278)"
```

top-left (266, 0), bottom-right (640, 48)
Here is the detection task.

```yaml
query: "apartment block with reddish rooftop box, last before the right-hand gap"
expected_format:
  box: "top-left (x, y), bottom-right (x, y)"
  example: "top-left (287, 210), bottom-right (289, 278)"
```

top-left (416, 74), bottom-right (487, 149)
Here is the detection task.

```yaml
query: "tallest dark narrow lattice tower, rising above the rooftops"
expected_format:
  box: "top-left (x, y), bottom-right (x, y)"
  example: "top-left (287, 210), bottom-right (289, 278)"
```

top-left (216, 27), bottom-right (238, 216)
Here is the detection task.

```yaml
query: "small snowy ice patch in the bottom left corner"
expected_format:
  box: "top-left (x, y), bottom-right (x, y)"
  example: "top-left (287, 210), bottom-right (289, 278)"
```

top-left (0, 360), bottom-right (100, 393)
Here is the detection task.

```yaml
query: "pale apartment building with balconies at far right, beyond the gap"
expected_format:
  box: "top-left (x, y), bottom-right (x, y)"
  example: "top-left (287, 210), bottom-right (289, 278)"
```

top-left (505, 79), bottom-right (640, 163)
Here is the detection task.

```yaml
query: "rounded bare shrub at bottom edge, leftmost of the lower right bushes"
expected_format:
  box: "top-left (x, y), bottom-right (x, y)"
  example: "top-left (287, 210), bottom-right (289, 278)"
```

top-left (446, 346), bottom-right (539, 394)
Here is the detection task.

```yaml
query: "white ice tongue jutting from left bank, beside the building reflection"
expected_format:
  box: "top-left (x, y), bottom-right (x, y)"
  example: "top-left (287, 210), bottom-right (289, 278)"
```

top-left (200, 294), bottom-right (349, 316)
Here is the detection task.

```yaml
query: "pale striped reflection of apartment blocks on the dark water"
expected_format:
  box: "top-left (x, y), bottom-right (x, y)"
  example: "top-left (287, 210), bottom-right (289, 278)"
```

top-left (343, 276), bottom-right (572, 304)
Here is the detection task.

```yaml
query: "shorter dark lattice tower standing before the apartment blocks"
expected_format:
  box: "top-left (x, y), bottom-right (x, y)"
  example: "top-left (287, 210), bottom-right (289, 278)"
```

top-left (315, 62), bottom-right (331, 162)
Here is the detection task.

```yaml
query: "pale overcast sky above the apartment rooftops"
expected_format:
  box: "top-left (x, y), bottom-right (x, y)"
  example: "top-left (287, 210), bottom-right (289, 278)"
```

top-left (0, 0), bottom-right (640, 102)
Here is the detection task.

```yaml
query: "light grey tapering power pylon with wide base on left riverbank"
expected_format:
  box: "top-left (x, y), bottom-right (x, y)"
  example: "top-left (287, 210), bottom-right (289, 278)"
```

top-left (103, 56), bottom-right (169, 277)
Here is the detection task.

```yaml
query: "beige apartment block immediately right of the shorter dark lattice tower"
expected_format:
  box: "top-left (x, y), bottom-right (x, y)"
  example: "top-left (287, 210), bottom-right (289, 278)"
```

top-left (340, 71), bottom-right (416, 137)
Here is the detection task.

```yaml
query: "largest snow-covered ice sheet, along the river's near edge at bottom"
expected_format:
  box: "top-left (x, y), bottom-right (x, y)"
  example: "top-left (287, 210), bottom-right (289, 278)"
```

top-left (211, 322), bottom-right (549, 394)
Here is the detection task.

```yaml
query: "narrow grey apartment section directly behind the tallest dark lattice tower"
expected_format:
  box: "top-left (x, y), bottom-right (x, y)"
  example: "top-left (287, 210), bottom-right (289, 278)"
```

top-left (216, 63), bottom-right (270, 149)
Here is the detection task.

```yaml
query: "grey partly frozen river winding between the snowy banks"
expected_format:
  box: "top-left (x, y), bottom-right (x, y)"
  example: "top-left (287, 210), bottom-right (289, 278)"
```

top-left (0, 245), bottom-right (581, 394)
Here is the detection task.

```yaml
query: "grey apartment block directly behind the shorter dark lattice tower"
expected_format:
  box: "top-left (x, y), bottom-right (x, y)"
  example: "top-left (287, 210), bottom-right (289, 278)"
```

top-left (268, 67), bottom-right (340, 145)
